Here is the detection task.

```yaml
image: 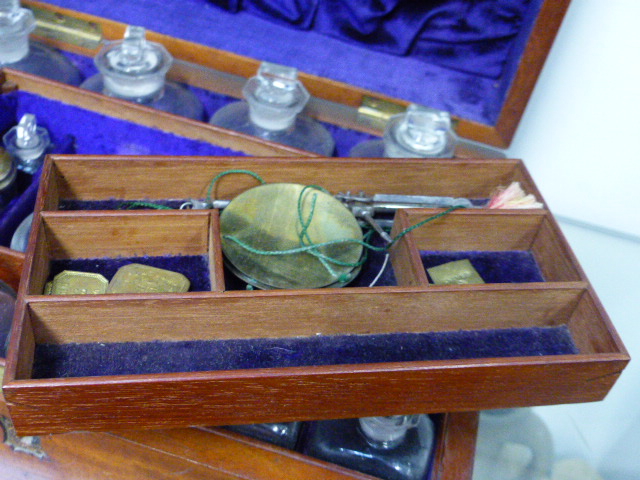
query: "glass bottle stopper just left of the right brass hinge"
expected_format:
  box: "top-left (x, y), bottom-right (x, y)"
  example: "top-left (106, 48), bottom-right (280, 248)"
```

top-left (242, 62), bottom-right (310, 130)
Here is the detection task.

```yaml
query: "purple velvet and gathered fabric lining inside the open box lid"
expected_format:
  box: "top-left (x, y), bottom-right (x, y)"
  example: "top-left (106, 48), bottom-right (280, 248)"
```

top-left (40, 0), bottom-right (542, 125)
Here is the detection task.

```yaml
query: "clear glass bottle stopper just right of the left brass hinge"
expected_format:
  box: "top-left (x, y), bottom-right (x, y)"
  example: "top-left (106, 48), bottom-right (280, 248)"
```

top-left (94, 25), bottom-right (173, 100)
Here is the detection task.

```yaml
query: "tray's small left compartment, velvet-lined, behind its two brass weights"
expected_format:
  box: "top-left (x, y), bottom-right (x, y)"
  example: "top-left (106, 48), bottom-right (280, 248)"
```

top-left (27, 211), bottom-right (224, 295)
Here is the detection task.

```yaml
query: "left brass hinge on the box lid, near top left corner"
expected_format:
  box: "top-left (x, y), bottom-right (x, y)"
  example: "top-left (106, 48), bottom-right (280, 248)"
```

top-left (29, 6), bottom-right (102, 50)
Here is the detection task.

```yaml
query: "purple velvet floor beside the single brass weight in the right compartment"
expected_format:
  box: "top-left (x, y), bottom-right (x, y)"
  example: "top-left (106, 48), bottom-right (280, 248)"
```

top-left (420, 250), bottom-right (544, 283)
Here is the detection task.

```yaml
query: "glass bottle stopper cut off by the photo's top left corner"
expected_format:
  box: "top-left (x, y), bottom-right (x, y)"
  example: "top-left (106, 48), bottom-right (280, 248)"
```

top-left (0, 0), bottom-right (36, 65)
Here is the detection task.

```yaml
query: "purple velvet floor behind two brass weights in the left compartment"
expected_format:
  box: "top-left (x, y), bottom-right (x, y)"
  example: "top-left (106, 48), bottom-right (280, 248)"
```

top-left (48, 255), bottom-right (211, 292)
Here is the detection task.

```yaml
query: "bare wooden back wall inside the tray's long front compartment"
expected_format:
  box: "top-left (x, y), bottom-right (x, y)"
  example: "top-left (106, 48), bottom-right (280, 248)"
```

top-left (27, 283), bottom-right (584, 344)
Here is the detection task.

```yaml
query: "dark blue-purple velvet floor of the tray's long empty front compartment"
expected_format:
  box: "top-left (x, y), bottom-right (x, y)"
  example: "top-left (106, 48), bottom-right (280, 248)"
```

top-left (33, 326), bottom-right (577, 378)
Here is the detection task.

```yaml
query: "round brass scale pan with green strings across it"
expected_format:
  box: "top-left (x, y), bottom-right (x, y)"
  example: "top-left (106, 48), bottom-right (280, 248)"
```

top-left (220, 183), bottom-right (363, 289)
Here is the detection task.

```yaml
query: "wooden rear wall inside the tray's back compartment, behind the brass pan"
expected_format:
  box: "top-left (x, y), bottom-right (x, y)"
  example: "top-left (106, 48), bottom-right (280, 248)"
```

top-left (43, 155), bottom-right (540, 204)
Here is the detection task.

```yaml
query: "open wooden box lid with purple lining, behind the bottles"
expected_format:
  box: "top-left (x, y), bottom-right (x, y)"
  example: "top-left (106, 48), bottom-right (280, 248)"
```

top-left (23, 0), bottom-right (569, 147)
